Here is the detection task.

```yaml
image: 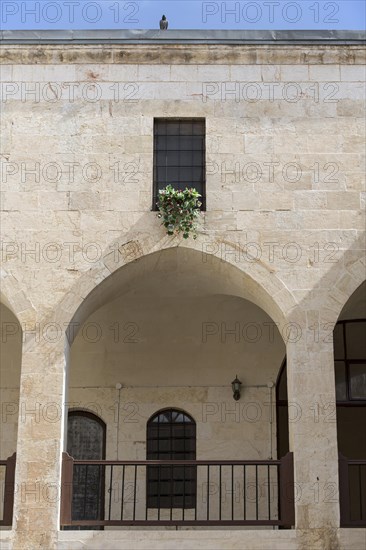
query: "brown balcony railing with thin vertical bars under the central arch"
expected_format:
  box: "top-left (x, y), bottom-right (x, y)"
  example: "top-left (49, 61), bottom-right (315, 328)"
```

top-left (61, 453), bottom-right (295, 529)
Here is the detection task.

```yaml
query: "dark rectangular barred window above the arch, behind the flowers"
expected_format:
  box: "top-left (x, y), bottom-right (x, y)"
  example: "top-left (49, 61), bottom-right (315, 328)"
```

top-left (153, 118), bottom-right (206, 210)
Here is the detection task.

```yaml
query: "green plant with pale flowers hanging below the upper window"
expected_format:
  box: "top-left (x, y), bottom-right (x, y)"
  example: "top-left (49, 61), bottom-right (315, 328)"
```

top-left (157, 185), bottom-right (201, 239)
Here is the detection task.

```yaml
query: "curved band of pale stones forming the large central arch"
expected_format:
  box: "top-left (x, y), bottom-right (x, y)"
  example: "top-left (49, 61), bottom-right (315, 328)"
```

top-left (60, 233), bottom-right (297, 344)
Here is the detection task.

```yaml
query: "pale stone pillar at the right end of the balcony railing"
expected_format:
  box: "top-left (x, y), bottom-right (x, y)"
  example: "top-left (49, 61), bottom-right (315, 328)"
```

top-left (287, 311), bottom-right (339, 550)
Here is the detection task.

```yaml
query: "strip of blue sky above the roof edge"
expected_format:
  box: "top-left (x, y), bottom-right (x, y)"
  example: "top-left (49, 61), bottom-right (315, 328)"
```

top-left (0, 0), bottom-right (366, 30)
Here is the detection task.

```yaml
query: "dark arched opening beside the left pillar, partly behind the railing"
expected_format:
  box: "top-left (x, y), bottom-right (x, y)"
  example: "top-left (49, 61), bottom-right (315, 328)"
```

top-left (67, 410), bottom-right (106, 529)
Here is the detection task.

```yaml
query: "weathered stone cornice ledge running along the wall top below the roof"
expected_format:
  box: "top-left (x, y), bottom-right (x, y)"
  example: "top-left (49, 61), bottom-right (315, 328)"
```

top-left (0, 42), bottom-right (366, 65)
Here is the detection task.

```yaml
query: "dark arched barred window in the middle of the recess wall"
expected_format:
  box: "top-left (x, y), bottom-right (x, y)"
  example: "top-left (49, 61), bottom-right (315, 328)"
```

top-left (146, 409), bottom-right (197, 508)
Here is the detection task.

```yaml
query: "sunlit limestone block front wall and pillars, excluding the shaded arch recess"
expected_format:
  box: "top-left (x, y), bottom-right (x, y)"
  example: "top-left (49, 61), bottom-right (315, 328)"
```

top-left (1, 45), bottom-right (365, 549)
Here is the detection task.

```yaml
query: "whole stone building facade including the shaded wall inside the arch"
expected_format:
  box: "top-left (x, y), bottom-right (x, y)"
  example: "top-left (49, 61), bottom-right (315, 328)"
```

top-left (0, 32), bottom-right (366, 550)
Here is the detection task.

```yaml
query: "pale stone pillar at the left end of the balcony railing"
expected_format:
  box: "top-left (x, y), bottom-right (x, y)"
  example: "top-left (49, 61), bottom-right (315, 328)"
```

top-left (13, 339), bottom-right (65, 550)
